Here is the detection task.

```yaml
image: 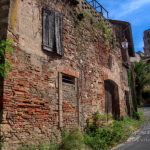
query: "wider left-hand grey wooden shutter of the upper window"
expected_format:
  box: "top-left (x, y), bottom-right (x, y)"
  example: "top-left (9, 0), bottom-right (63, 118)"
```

top-left (43, 7), bottom-right (55, 51)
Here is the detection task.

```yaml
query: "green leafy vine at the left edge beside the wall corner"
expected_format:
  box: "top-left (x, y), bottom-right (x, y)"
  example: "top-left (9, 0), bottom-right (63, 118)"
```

top-left (0, 39), bottom-right (13, 78)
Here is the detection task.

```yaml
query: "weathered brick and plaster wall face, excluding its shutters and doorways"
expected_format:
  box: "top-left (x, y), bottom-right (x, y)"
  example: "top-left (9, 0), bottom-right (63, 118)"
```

top-left (2, 0), bottom-right (128, 150)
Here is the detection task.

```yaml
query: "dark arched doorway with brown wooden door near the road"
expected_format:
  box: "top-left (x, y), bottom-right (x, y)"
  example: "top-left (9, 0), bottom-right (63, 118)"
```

top-left (104, 80), bottom-right (120, 119)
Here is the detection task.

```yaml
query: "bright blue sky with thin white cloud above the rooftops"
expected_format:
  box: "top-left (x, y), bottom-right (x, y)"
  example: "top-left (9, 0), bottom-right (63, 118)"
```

top-left (98, 0), bottom-right (150, 51)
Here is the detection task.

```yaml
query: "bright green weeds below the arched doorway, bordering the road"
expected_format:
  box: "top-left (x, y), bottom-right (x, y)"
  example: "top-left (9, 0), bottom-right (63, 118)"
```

top-left (84, 113), bottom-right (144, 150)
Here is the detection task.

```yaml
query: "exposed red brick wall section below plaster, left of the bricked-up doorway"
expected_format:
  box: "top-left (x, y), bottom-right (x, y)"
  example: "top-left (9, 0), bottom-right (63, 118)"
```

top-left (3, 48), bottom-right (59, 148)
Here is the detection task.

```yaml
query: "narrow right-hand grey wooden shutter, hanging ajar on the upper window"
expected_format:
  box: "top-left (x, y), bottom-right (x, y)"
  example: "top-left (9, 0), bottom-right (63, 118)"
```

top-left (55, 12), bottom-right (64, 56)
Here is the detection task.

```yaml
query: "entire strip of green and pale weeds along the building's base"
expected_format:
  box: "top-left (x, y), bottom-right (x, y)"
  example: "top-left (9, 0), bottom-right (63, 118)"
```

top-left (18, 112), bottom-right (145, 150)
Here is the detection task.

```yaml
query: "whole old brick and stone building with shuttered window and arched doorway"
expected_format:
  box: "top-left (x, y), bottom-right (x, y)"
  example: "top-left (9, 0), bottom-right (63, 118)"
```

top-left (0, 0), bottom-right (134, 150)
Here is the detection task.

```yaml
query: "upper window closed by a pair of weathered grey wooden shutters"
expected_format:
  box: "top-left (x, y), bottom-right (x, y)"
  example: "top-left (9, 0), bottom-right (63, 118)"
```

top-left (43, 7), bottom-right (63, 56)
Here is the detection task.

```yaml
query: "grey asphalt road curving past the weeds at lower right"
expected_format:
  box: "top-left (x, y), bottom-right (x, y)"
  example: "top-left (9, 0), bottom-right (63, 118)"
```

top-left (112, 107), bottom-right (150, 150)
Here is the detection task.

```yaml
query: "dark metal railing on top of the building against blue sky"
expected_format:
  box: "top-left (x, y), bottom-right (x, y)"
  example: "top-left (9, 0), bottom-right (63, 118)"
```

top-left (86, 0), bottom-right (109, 18)
